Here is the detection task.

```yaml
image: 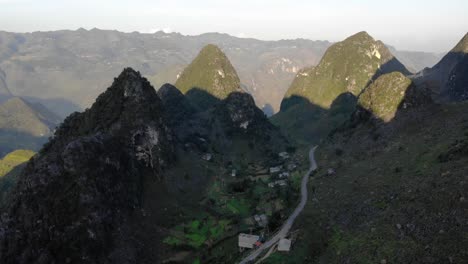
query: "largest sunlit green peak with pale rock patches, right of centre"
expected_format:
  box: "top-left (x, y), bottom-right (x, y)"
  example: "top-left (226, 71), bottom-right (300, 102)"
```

top-left (281, 32), bottom-right (409, 110)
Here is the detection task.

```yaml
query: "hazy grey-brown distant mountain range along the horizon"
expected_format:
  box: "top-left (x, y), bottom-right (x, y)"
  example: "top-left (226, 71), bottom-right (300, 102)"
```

top-left (0, 29), bottom-right (446, 117)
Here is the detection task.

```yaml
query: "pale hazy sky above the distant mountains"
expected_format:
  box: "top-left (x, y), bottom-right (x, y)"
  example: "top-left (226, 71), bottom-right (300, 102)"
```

top-left (0, 0), bottom-right (468, 52)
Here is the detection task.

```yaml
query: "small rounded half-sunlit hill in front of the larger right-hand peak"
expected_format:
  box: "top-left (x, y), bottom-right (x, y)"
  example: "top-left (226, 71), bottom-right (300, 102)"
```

top-left (358, 72), bottom-right (431, 122)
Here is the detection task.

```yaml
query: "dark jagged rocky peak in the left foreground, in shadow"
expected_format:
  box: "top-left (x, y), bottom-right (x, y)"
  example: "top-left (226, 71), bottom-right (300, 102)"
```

top-left (0, 69), bottom-right (173, 263)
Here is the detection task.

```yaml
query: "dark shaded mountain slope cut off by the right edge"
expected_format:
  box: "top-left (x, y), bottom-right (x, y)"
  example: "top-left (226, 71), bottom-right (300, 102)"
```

top-left (412, 34), bottom-right (468, 102)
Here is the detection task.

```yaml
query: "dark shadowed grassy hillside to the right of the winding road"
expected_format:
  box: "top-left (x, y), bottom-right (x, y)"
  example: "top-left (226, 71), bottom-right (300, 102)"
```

top-left (278, 103), bottom-right (468, 263)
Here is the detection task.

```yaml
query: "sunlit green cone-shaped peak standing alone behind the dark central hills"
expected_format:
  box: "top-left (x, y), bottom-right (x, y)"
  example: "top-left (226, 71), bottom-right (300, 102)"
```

top-left (175, 45), bottom-right (242, 107)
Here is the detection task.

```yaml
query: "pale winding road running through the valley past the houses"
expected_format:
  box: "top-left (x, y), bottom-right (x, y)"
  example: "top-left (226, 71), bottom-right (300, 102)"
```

top-left (239, 146), bottom-right (317, 264)
